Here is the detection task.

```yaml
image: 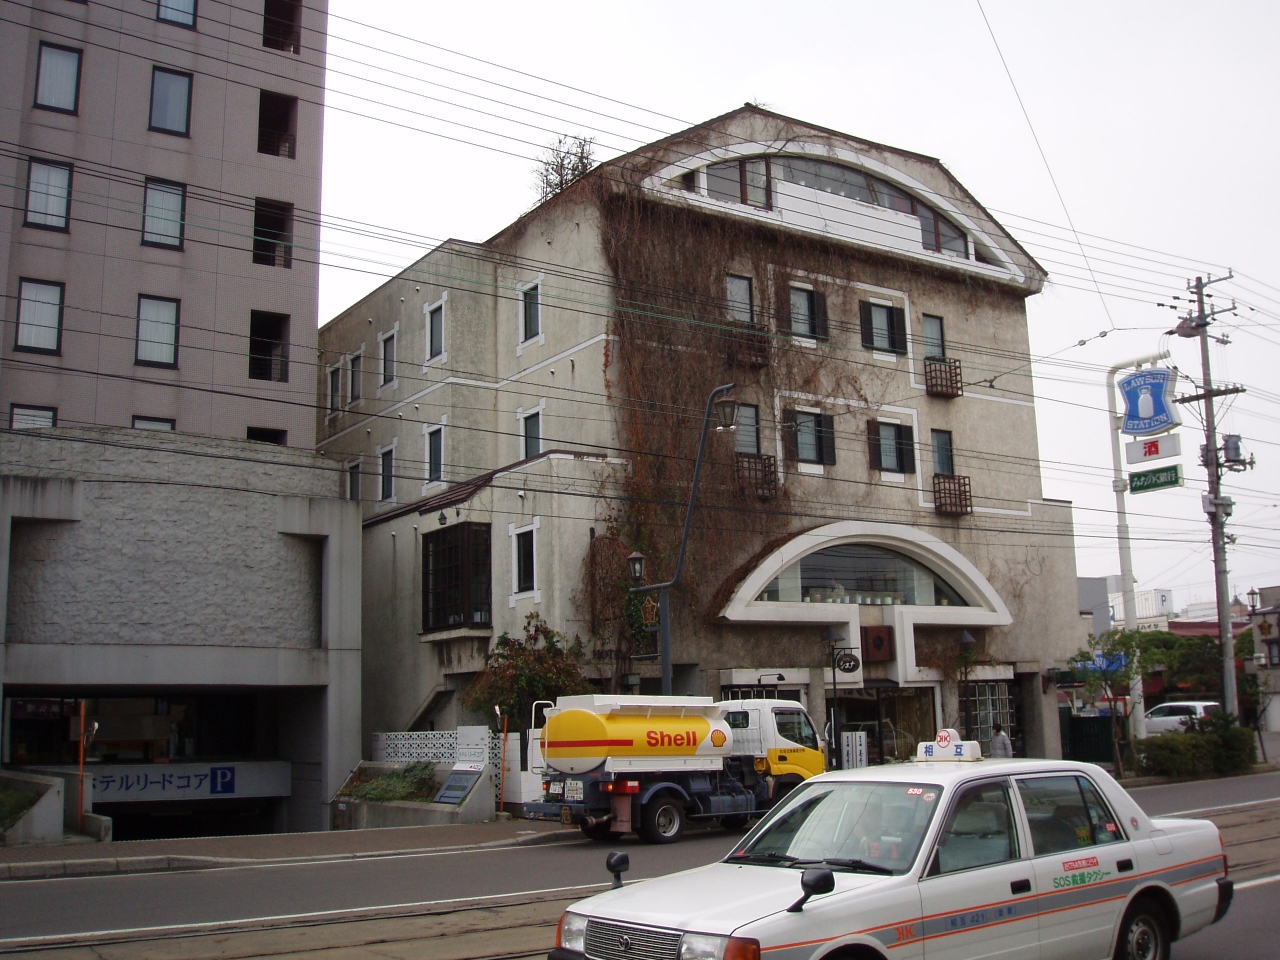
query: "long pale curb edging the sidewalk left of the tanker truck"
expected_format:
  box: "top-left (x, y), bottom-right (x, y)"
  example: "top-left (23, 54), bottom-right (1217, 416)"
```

top-left (0, 829), bottom-right (582, 881)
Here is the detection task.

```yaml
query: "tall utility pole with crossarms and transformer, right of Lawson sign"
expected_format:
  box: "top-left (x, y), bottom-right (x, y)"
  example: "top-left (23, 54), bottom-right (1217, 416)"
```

top-left (1175, 273), bottom-right (1244, 716)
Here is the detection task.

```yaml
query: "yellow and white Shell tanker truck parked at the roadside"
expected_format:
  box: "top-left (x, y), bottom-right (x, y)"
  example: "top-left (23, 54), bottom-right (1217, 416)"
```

top-left (525, 694), bottom-right (826, 844)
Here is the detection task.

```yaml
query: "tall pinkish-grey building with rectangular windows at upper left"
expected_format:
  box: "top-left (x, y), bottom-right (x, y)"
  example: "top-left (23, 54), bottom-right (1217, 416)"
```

top-left (0, 0), bottom-right (328, 448)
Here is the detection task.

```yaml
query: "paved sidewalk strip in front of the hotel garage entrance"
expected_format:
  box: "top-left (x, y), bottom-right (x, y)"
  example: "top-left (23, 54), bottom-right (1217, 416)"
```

top-left (0, 820), bottom-right (581, 881)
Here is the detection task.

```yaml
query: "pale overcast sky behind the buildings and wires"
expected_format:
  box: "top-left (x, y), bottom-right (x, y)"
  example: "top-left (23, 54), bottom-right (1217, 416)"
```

top-left (320, 0), bottom-right (1280, 605)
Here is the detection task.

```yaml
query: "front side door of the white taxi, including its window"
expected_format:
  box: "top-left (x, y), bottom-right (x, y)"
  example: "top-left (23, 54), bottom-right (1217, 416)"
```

top-left (920, 778), bottom-right (1039, 960)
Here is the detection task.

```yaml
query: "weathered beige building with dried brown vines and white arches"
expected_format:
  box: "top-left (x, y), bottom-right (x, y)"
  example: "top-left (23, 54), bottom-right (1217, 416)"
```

top-left (317, 106), bottom-right (1084, 759)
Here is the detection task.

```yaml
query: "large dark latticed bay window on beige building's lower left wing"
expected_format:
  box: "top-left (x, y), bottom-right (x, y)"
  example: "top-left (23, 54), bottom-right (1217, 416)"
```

top-left (422, 524), bottom-right (493, 634)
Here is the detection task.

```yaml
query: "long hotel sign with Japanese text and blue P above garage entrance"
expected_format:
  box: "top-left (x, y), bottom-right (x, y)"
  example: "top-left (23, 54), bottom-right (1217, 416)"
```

top-left (93, 760), bottom-right (292, 804)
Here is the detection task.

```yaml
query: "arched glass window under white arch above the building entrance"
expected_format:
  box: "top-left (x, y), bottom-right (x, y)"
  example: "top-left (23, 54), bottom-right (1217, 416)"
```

top-left (755, 543), bottom-right (969, 607)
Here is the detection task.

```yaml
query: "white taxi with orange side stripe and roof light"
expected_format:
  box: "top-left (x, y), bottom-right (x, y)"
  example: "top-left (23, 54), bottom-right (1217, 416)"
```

top-left (548, 730), bottom-right (1231, 960)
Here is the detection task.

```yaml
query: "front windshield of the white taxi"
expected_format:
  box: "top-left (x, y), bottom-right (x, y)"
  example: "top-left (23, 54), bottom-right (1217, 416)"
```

top-left (728, 782), bottom-right (942, 874)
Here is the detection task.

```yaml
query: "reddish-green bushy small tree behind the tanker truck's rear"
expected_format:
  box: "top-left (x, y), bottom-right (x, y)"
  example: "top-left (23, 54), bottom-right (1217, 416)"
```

top-left (462, 613), bottom-right (591, 730)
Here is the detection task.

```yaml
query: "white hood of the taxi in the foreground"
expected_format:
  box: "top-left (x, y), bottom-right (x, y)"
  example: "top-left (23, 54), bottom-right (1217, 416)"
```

top-left (568, 863), bottom-right (895, 936)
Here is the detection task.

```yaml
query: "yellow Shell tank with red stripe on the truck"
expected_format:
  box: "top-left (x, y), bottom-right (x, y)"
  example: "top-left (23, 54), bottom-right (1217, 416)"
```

top-left (541, 696), bottom-right (733, 773)
